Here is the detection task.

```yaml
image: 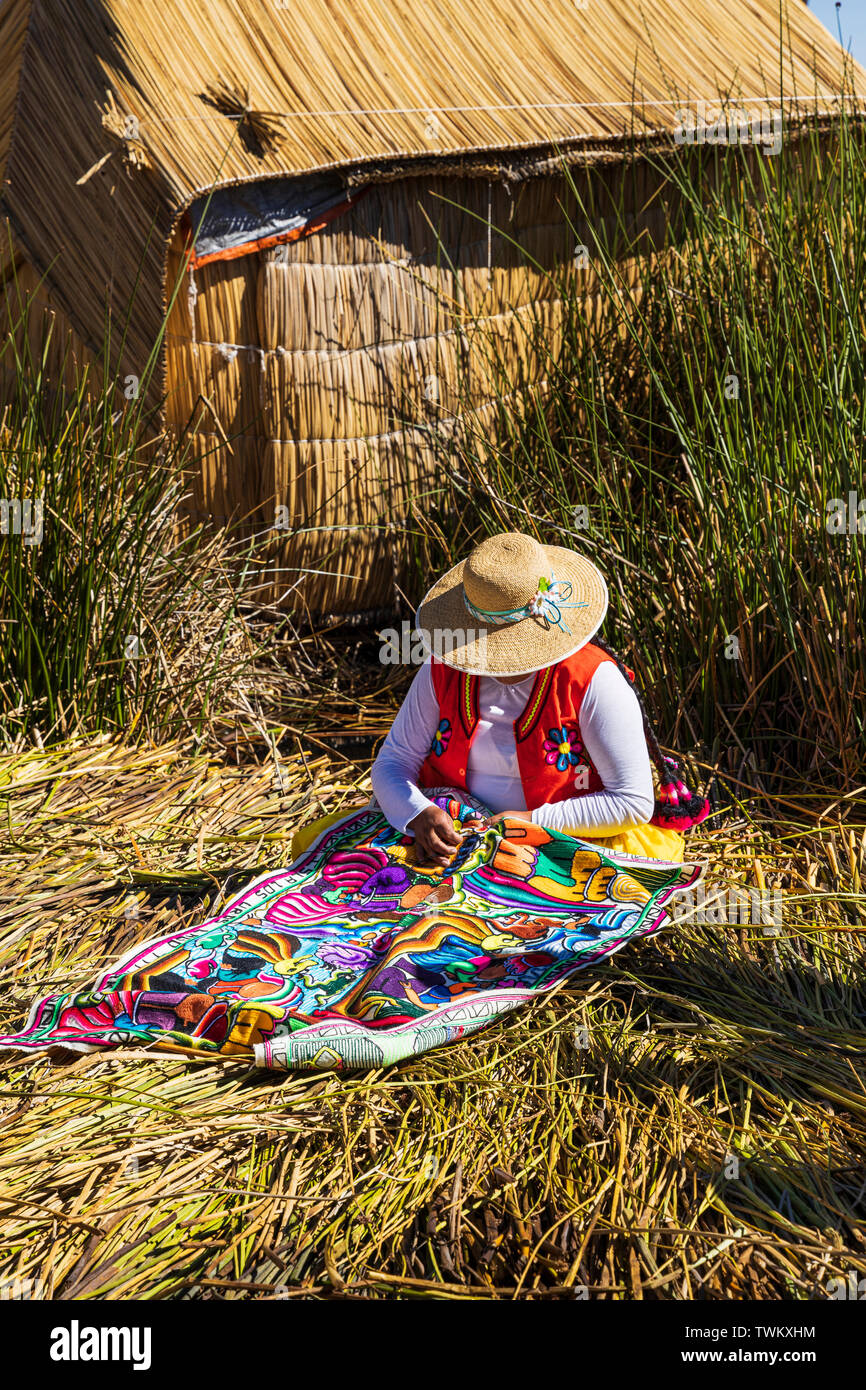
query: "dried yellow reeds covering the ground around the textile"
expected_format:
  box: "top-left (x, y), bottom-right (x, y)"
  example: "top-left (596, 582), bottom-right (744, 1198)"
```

top-left (0, 738), bottom-right (866, 1300)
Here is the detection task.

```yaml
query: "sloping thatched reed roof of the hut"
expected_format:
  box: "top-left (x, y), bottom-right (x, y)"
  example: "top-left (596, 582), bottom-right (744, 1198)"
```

top-left (0, 0), bottom-right (866, 369)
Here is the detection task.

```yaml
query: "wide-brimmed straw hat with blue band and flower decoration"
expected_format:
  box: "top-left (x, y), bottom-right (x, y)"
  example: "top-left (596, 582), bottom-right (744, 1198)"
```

top-left (416, 531), bottom-right (607, 676)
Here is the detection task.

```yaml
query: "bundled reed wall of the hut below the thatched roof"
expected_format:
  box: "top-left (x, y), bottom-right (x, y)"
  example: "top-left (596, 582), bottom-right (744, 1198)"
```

top-left (167, 163), bottom-right (664, 612)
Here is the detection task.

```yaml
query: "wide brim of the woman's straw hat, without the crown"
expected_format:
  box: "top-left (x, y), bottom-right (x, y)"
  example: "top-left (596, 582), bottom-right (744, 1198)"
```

top-left (416, 545), bottom-right (607, 676)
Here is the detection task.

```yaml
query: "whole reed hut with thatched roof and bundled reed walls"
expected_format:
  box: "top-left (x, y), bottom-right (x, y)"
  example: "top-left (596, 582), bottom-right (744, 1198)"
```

top-left (0, 0), bottom-right (842, 610)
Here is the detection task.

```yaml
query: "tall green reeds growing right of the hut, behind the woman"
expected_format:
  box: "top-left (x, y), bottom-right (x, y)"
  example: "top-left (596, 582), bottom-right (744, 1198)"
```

top-left (416, 113), bottom-right (866, 795)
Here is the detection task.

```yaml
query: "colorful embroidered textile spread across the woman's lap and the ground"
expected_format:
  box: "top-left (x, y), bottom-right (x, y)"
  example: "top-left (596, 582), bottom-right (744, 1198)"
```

top-left (0, 791), bottom-right (702, 1068)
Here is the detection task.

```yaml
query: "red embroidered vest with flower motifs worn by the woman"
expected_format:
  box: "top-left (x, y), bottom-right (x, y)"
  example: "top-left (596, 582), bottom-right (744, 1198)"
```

top-left (418, 646), bottom-right (610, 810)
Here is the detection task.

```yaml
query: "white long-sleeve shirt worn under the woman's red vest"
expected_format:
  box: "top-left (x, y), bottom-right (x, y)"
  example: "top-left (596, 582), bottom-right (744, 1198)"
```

top-left (373, 662), bottom-right (655, 834)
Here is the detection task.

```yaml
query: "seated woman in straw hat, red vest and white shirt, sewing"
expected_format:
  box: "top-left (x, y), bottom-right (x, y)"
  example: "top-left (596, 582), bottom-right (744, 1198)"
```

top-left (369, 532), bottom-right (709, 867)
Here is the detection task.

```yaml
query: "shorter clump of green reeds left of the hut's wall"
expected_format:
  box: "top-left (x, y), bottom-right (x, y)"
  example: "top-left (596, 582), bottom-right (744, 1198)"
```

top-left (0, 275), bottom-right (273, 739)
